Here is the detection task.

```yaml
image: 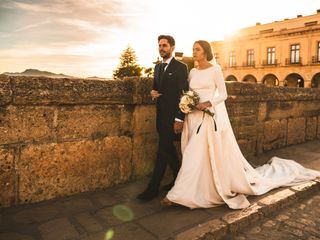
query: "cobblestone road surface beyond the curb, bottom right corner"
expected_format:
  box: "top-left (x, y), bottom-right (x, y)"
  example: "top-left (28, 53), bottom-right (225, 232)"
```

top-left (234, 193), bottom-right (320, 240)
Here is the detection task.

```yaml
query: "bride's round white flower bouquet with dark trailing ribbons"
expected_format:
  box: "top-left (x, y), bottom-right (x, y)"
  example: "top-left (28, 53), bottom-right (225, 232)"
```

top-left (179, 90), bottom-right (217, 134)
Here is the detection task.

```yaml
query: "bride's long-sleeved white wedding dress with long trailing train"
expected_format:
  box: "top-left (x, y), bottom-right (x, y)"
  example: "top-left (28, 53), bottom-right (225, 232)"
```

top-left (167, 65), bottom-right (320, 209)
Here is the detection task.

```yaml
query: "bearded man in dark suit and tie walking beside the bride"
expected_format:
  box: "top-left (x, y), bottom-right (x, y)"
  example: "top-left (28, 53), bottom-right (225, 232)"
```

top-left (138, 35), bottom-right (188, 200)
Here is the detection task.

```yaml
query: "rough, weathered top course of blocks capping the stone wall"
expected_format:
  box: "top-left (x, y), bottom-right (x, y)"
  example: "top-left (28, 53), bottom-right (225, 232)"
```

top-left (0, 74), bottom-right (320, 105)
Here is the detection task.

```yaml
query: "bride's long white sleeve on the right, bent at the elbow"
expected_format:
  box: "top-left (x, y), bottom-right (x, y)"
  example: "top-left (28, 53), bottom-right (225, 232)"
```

top-left (210, 65), bottom-right (228, 107)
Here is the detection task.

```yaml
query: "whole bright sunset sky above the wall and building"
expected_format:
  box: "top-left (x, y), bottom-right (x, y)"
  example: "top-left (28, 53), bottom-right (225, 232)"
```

top-left (0, 0), bottom-right (320, 77)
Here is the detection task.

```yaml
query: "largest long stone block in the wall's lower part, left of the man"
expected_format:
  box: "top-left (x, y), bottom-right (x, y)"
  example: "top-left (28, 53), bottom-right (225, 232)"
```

top-left (19, 137), bottom-right (132, 203)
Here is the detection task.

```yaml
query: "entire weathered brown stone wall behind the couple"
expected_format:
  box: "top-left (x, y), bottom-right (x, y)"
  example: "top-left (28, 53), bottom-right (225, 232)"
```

top-left (0, 75), bottom-right (320, 207)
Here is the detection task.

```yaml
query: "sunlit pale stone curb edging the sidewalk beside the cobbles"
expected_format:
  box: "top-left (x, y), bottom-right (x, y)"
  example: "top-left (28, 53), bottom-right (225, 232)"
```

top-left (173, 178), bottom-right (320, 240)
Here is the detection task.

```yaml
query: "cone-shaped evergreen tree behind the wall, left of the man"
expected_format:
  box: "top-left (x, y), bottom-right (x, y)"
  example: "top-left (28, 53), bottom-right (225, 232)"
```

top-left (113, 46), bottom-right (142, 79)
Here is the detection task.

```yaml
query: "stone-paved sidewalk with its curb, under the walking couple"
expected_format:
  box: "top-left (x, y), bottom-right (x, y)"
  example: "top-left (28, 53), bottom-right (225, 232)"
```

top-left (0, 141), bottom-right (320, 240)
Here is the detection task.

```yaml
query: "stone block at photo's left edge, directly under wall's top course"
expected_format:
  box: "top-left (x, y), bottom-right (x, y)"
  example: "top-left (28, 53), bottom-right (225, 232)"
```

top-left (0, 106), bottom-right (54, 144)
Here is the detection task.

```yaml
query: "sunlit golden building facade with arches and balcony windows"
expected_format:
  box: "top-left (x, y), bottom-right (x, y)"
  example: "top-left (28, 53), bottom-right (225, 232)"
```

top-left (211, 10), bottom-right (320, 88)
